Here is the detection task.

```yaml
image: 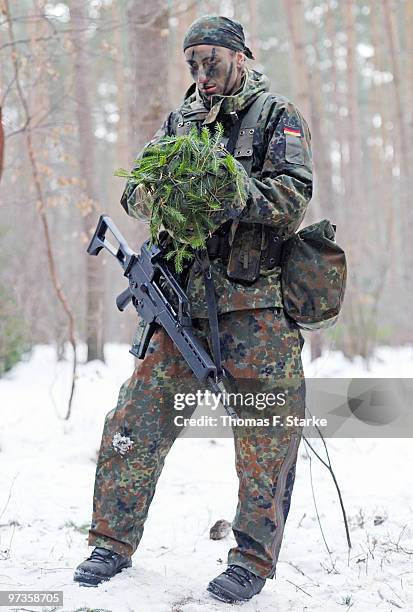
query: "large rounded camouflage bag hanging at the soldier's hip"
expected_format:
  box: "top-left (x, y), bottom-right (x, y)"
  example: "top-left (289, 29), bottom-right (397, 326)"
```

top-left (281, 219), bottom-right (347, 330)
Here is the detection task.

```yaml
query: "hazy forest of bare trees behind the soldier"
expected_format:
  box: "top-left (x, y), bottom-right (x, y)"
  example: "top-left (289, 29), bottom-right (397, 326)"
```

top-left (0, 0), bottom-right (413, 375)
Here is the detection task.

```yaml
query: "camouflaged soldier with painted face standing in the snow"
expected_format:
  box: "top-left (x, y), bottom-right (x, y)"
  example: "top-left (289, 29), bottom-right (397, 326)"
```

top-left (74, 15), bottom-right (312, 602)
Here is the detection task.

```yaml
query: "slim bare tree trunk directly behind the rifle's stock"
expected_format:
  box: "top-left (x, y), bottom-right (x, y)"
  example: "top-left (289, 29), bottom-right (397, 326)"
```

top-left (70, 0), bottom-right (104, 361)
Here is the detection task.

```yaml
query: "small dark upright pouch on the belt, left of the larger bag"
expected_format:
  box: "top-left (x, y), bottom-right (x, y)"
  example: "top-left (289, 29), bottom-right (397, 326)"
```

top-left (227, 222), bottom-right (263, 284)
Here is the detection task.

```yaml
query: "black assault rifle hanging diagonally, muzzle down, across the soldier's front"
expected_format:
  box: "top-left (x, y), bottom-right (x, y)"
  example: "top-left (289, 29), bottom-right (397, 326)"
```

top-left (87, 215), bottom-right (237, 418)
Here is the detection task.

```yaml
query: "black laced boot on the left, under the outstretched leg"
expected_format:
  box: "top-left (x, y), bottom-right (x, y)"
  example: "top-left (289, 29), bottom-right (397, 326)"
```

top-left (73, 547), bottom-right (132, 586)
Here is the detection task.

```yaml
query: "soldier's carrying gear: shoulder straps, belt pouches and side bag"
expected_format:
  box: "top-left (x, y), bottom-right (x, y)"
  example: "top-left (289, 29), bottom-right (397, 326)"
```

top-left (173, 93), bottom-right (347, 330)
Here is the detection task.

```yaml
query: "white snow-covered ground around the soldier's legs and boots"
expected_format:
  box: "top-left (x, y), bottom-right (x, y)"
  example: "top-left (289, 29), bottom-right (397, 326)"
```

top-left (0, 345), bottom-right (413, 612)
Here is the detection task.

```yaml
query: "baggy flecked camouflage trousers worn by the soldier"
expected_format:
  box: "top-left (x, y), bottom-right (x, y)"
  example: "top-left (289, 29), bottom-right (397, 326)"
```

top-left (89, 308), bottom-right (305, 578)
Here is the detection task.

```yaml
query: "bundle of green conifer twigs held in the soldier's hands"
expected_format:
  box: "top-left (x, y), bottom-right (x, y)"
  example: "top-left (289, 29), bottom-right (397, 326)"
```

top-left (115, 124), bottom-right (246, 272)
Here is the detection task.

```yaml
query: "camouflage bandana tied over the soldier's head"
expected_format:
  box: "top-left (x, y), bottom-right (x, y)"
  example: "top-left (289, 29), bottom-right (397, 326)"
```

top-left (183, 15), bottom-right (254, 59)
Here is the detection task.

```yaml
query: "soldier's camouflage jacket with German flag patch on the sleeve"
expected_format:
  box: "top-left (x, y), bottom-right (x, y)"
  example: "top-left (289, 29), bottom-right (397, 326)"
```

top-left (121, 70), bottom-right (312, 318)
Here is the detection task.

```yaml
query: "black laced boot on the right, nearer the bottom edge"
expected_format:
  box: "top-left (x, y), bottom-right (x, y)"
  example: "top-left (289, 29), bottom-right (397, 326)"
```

top-left (207, 565), bottom-right (265, 603)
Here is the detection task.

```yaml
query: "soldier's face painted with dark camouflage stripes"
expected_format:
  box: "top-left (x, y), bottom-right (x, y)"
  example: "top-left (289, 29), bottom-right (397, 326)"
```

top-left (185, 45), bottom-right (245, 96)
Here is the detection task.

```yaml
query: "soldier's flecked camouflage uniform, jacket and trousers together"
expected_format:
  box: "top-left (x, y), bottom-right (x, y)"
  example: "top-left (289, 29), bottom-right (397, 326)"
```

top-left (89, 70), bottom-right (312, 578)
